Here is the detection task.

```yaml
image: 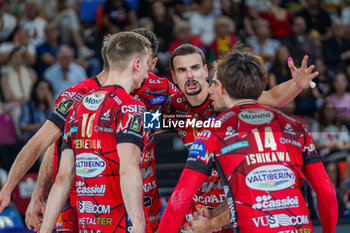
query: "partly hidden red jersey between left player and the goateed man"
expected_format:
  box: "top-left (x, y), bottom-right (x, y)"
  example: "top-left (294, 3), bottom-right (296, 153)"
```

top-left (132, 73), bottom-right (178, 232)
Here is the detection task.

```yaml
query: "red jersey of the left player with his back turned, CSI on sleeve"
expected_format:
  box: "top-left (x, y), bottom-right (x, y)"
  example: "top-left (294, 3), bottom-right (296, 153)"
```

top-left (63, 85), bottom-right (145, 233)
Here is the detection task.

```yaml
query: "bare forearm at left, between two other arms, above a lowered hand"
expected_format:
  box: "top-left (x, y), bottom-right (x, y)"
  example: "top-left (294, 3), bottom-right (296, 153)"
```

top-left (32, 144), bottom-right (55, 199)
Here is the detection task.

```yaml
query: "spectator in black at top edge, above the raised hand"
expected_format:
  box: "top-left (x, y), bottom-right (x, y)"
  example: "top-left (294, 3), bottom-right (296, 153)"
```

top-left (296, 0), bottom-right (331, 41)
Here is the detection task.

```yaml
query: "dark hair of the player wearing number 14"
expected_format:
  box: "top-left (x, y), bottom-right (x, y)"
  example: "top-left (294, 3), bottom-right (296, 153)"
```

top-left (217, 50), bottom-right (267, 99)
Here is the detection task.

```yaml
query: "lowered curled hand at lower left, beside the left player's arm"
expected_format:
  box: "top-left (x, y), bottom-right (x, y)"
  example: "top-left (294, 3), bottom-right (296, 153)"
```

top-left (25, 197), bottom-right (45, 230)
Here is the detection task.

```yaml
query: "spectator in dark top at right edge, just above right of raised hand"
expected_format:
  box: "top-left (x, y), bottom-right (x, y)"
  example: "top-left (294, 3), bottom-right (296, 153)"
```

top-left (322, 19), bottom-right (350, 72)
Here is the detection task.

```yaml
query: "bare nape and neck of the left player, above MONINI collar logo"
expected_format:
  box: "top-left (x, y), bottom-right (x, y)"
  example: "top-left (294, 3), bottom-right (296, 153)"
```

top-left (104, 70), bottom-right (134, 94)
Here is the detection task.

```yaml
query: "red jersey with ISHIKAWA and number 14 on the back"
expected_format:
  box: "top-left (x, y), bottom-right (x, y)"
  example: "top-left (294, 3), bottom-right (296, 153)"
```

top-left (186, 105), bottom-right (320, 233)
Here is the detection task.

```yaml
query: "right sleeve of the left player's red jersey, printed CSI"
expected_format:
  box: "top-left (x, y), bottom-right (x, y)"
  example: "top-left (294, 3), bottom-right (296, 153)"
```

top-left (116, 101), bottom-right (146, 151)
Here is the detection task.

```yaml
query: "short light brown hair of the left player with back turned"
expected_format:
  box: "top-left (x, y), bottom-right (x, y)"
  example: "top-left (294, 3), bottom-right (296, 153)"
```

top-left (106, 32), bottom-right (151, 69)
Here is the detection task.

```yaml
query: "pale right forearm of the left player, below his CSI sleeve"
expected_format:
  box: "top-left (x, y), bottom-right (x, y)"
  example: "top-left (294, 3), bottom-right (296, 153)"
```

top-left (120, 165), bottom-right (146, 225)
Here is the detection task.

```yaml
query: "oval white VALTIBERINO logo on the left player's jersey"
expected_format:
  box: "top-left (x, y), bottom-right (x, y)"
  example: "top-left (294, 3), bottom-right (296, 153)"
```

top-left (76, 153), bottom-right (106, 178)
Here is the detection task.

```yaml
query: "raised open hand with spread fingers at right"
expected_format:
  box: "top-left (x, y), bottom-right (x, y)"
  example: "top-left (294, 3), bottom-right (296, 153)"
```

top-left (288, 55), bottom-right (319, 89)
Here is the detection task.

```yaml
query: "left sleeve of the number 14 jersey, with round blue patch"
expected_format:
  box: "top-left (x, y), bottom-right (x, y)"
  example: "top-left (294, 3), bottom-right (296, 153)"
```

top-left (185, 129), bottom-right (215, 176)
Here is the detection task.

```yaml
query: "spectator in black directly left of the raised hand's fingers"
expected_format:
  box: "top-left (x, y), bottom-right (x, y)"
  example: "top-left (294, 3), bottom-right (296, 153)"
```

top-left (268, 46), bottom-right (291, 88)
